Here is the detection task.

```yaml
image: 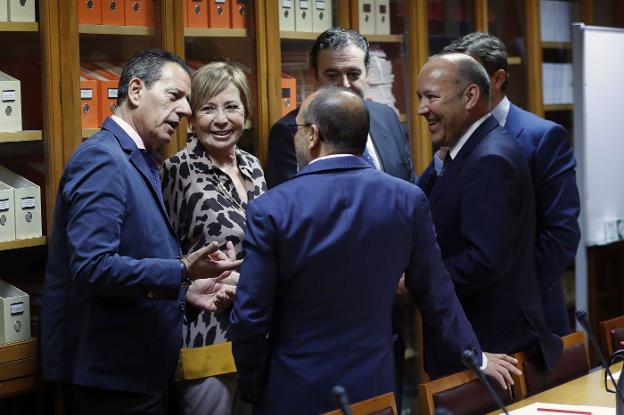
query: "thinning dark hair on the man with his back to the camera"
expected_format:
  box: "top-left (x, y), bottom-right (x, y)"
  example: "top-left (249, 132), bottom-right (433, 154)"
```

top-left (301, 86), bottom-right (370, 154)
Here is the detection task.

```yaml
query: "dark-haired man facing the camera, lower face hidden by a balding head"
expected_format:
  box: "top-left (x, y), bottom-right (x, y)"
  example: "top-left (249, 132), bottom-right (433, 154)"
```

top-left (264, 27), bottom-right (416, 188)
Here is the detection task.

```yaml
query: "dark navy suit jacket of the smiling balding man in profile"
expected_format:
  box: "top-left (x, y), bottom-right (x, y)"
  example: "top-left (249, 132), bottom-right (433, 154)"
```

top-left (421, 116), bottom-right (561, 377)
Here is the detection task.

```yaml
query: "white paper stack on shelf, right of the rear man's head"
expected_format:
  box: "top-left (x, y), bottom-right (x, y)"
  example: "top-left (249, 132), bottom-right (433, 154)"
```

top-left (364, 49), bottom-right (399, 115)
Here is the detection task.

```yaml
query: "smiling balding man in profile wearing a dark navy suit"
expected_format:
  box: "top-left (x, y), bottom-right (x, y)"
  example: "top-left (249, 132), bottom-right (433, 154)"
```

top-left (418, 53), bottom-right (562, 377)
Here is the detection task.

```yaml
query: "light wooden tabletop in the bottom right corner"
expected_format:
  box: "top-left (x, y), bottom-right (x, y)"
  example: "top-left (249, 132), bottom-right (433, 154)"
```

top-left (490, 363), bottom-right (622, 415)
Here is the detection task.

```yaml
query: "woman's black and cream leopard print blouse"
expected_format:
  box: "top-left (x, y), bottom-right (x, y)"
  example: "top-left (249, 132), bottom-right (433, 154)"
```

top-left (162, 137), bottom-right (267, 348)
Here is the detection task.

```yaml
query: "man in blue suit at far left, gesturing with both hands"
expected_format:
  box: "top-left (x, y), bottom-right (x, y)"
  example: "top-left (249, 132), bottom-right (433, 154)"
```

top-left (41, 49), bottom-right (240, 415)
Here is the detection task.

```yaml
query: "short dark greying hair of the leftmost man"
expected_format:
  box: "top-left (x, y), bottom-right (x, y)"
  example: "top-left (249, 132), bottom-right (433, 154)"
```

top-left (117, 49), bottom-right (191, 105)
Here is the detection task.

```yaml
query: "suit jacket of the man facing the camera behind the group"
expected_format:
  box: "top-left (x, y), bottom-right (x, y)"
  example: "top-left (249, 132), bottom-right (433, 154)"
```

top-left (264, 100), bottom-right (416, 188)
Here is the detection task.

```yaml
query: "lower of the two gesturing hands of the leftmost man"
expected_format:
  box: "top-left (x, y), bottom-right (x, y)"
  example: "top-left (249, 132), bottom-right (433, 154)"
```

top-left (186, 273), bottom-right (236, 312)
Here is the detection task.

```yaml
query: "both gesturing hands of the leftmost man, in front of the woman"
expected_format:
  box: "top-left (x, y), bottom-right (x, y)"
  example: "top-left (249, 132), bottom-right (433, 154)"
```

top-left (182, 241), bottom-right (243, 312)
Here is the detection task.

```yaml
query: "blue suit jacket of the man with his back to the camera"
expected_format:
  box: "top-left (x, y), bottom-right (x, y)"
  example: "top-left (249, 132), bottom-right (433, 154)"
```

top-left (230, 157), bottom-right (481, 414)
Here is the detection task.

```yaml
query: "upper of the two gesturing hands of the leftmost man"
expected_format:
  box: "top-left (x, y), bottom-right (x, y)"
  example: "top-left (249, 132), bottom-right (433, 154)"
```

top-left (182, 242), bottom-right (243, 280)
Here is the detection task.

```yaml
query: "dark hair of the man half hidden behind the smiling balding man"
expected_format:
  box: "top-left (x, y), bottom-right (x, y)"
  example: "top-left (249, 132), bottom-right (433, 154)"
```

top-left (443, 32), bottom-right (509, 91)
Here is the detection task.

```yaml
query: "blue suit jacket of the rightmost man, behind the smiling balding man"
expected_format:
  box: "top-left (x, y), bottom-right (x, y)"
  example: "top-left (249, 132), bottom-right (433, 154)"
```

top-left (505, 104), bottom-right (581, 335)
